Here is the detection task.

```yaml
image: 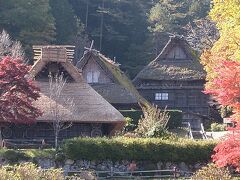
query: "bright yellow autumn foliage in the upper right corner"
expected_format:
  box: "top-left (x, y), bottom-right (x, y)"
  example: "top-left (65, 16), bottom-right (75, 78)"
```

top-left (201, 0), bottom-right (240, 83)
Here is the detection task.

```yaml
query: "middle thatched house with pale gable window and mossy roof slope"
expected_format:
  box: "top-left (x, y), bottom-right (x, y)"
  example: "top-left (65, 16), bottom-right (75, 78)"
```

top-left (77, 49), bottom-right (142, 108)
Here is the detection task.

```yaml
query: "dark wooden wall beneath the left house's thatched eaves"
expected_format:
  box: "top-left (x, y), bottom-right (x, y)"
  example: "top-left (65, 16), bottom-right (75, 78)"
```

top-left (1, 123), bottom-right (110, 142)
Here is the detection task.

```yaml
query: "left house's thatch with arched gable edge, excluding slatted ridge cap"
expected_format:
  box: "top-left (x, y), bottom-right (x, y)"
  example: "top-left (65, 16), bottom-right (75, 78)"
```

top-left (29, 46), bottom-right (124, 131)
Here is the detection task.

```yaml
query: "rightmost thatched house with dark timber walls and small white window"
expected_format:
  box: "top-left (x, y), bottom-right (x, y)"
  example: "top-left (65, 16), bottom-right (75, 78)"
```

top-left (133, 36), bottom-right (208, 128)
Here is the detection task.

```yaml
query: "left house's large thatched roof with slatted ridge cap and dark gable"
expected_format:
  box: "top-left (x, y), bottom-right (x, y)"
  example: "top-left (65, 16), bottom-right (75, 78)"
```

top-left (29, 46), bottom-right (124, 136)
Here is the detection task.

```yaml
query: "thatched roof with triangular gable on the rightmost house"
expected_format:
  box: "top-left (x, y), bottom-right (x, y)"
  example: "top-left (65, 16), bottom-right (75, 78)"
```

top-left (134, 36), bottom-right (206, 82)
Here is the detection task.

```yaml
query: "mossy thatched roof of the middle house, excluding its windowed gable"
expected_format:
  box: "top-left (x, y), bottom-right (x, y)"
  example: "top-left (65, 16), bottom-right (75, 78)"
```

top-left (77, 50), bottom-right (142, 104)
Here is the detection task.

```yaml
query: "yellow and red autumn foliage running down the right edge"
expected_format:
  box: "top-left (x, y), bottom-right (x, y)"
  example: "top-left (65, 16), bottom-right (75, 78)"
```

top-left (201, 0), bottom-right (240, 171)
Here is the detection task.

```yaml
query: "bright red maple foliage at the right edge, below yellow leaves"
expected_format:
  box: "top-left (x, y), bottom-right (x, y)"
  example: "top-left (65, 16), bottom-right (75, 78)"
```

top-left (205, 61), bottom-right (240, 172)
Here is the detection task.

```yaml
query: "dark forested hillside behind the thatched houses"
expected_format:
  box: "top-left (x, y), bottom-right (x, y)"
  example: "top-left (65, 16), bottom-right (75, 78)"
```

top-left (0, 0), bottom-right (210, 78)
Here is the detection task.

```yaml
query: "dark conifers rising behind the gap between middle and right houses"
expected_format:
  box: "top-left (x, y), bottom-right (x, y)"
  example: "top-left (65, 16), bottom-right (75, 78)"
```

top-left (70, 0), bottom-right (153, 77)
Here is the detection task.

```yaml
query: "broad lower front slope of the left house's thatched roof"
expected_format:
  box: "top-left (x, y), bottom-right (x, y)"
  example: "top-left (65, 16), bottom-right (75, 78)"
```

top-left (36, 82), bottom-right (124, 123)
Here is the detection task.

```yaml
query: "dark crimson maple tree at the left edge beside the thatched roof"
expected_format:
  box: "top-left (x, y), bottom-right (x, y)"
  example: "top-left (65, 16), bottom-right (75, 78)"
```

top-left (0, 57), bottom-right (41, 124)
